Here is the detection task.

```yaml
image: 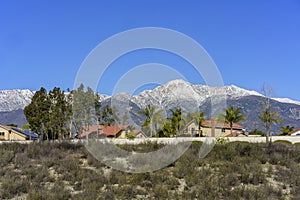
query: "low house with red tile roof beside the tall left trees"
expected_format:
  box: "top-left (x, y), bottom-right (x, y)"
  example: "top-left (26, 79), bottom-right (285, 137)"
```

top-left (76, 125), bottom-right (129, 139)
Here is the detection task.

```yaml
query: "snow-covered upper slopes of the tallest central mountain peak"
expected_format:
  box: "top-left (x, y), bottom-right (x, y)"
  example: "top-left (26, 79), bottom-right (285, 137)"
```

top-left (132, 80), bottom-right (263, 110)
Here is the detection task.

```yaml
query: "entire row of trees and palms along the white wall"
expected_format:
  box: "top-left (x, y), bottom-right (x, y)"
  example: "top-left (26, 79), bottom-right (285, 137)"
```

top-left (24, 84), bottom-right (293, 142)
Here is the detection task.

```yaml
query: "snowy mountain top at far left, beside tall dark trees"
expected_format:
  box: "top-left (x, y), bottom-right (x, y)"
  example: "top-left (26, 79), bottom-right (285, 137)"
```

top-left (0, 90), bottom-right (34, 112)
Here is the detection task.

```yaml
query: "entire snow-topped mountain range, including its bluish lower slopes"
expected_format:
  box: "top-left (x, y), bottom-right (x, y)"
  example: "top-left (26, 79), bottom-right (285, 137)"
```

top-left (0, 80), bottom-right (300, 132)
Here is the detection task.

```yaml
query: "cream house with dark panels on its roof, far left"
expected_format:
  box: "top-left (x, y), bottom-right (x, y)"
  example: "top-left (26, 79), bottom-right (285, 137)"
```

top-left (0, 125), bottom-right (39, 141)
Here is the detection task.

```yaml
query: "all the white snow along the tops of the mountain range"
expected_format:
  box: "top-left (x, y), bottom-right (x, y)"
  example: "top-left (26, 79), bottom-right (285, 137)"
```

top-left (0, 79), bottom-right (300, 112)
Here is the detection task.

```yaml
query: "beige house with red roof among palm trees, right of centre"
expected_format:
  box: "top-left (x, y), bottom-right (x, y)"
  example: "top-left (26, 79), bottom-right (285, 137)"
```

top-left (183, 119), bottom-right (246, 137)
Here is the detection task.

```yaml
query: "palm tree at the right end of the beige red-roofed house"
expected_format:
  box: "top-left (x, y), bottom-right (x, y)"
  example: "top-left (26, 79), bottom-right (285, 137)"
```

top-left (221, 106), bottom-right (245, 134)
